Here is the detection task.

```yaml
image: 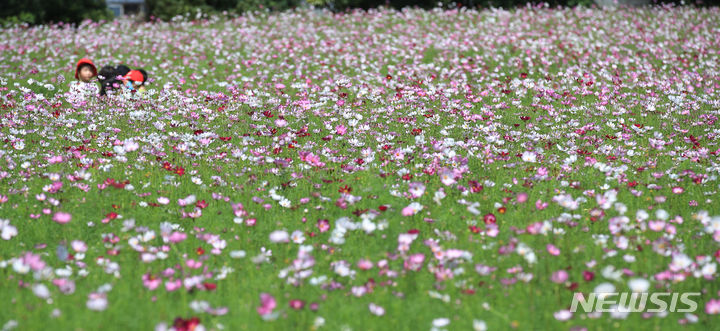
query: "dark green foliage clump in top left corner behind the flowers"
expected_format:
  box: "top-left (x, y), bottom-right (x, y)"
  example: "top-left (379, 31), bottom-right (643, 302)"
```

top-left (0, 0), bottom-right (112, 25)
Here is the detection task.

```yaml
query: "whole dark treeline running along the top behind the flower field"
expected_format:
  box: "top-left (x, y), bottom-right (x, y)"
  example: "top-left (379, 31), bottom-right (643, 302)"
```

top-left (0, 0), bottom-right (708, 25)
